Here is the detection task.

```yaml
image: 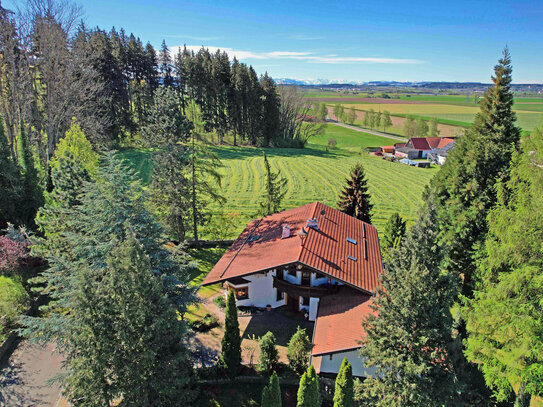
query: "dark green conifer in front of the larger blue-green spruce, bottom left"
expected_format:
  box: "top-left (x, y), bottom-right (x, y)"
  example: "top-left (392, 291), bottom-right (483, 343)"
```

top-left (67, 228), bottom-right (194, 406)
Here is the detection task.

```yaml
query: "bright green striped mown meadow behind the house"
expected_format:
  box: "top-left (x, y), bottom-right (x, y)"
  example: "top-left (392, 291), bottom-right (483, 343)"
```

top-left (121, 125), bottom-right (438, 237)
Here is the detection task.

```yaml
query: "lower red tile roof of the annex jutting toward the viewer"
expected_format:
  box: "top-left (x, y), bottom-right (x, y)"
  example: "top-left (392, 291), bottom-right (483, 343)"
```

top-left (311, 286), bottom-right (375, 356)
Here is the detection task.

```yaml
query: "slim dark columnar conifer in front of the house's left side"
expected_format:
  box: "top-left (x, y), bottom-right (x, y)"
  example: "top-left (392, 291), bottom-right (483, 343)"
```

top-left (221, 290), bottom-right (241, 378)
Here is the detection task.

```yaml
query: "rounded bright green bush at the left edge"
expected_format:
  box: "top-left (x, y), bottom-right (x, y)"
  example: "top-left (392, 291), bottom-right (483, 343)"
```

top-left (0, 276), bottom-right (28, 341)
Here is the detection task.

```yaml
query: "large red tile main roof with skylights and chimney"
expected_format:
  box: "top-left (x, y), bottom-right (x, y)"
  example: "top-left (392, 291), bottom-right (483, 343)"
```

top-left (202, 202), bottom-right (383, 292)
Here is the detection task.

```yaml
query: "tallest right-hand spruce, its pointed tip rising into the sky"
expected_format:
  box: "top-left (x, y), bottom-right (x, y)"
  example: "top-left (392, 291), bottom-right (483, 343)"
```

top-left (430, 48), bottom-right (520, 297)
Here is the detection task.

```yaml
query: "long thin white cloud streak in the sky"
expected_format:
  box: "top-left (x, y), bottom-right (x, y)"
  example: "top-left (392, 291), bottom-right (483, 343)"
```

top-left (170, 45), bottom-right (424, 64)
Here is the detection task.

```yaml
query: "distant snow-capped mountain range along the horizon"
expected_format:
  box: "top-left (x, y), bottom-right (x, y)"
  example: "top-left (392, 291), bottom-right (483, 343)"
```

top-left (274, 78), bottom-right (543, 92)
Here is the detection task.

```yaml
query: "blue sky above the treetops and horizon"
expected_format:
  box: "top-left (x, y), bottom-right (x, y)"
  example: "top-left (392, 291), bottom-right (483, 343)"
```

top-left (15, 0), bottom-right (543, 83)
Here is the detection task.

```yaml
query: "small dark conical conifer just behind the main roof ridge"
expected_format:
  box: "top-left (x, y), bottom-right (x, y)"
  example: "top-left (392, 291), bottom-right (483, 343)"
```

top-left (337, 164), bottom-right (373, 223)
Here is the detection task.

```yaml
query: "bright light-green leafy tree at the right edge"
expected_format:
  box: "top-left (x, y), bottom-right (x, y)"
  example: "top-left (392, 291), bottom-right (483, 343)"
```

top-left (465, 130), bottom-right (543, 407)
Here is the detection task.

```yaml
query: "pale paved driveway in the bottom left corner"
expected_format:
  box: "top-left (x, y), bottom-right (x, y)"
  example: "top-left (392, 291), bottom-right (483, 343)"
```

top-left (0, 341), bottom-right (63, 407)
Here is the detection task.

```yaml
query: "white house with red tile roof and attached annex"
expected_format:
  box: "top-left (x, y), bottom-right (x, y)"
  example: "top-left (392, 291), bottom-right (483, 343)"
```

top-left (203, 202), bottom-right (383, 377)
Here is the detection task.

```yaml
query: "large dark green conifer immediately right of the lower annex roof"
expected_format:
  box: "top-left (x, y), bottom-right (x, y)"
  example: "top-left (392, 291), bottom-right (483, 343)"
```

top-left (361, 201), bottom-right (459, 407)
